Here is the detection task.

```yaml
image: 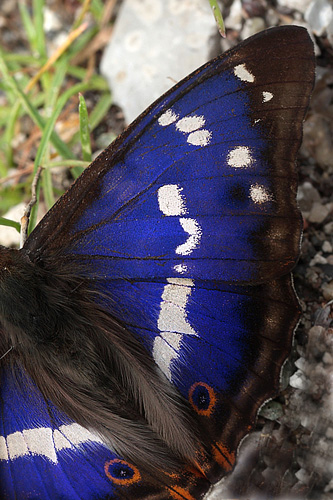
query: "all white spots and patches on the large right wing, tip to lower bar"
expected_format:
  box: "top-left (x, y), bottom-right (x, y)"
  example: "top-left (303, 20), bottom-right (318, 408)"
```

top-left (153, 59), bottom-right (273, 379)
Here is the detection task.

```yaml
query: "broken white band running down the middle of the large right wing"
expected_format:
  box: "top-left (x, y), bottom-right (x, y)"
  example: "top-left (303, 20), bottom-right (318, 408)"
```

top-left (153, 187), bottom-right (202, 380)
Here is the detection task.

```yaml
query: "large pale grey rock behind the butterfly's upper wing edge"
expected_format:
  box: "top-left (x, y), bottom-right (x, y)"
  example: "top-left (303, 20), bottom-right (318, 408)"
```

top-left (101, 0), bottom-right (217, 123)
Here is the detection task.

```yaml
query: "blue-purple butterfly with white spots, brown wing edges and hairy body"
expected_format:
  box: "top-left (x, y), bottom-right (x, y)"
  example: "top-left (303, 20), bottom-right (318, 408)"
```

top-left (0, 26), bottom-right (315, 500)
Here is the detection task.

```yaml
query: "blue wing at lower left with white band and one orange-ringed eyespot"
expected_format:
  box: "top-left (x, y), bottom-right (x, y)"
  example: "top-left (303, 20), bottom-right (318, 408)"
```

top-left (0, 370), bottom-right (187, 500)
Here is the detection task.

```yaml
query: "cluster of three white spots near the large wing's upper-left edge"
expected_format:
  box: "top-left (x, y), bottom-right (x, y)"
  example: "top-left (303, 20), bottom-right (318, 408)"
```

top-left (158, 109), bottom-right (212, 146)
